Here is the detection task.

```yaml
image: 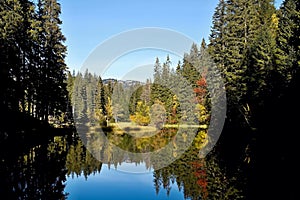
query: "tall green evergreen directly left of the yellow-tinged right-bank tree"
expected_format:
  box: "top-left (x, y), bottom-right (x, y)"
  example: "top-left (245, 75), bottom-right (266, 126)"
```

top-left (221, 0), bottom-right (258, 108)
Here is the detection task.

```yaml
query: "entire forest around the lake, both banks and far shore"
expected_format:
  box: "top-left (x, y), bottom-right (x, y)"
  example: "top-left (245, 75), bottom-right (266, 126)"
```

top-left (0, 0), bottom-right (300, 199)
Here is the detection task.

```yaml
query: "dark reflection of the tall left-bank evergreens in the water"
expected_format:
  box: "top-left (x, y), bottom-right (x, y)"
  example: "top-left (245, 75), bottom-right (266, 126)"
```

top-left (0, 137), bottom-right (67, 199)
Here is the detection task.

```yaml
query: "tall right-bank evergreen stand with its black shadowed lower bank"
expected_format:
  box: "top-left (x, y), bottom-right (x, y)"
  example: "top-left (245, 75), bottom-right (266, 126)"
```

top-left (209, 0), bottom-right (300, 199)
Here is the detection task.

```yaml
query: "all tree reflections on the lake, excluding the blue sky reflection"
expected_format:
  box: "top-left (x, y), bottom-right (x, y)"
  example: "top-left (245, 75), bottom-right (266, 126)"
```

top-left (0, 129), bottom-right (243, 199)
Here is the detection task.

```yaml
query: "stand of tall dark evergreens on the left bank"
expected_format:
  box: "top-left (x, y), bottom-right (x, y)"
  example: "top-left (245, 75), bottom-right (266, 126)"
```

top-left (0, 0), bottom-right (68, 121)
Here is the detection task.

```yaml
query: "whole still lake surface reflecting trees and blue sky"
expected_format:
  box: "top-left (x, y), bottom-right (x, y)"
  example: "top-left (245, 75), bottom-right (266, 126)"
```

top-left (0, 130), bottom-right (242, 200)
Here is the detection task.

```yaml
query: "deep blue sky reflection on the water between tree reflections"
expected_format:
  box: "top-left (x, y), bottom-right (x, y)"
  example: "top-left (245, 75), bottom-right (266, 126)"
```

top-left (65, 164), bottom-right (184, 200)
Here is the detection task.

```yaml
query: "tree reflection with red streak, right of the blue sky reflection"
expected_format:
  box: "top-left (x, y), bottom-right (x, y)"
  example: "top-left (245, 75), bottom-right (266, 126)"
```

top-left (153, 138), bottom-right (243, 200)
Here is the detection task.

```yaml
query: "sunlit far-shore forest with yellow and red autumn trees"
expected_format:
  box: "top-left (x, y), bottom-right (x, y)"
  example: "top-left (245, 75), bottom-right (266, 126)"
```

top-left (68, 48), bottom-right (209, 126)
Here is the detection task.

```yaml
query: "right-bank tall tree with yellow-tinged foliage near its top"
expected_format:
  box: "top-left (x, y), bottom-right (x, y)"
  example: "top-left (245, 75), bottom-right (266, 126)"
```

top-left (247, 1), bottom-right (278, 108)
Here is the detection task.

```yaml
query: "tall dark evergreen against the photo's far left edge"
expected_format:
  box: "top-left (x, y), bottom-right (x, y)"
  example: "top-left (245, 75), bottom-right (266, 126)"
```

top-left (0, 1), bottom-right (24, 110)
